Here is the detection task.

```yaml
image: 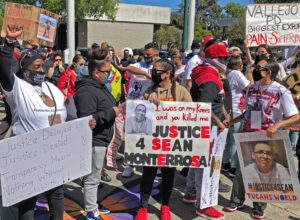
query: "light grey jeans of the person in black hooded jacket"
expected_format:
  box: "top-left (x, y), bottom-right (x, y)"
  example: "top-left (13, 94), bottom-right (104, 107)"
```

top-left (83, 146), bottom-right (106, 212)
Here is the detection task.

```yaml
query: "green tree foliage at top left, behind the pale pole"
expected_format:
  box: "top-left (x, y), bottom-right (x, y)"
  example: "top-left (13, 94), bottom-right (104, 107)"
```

top-left (3, 0), bottom-right (120, 21)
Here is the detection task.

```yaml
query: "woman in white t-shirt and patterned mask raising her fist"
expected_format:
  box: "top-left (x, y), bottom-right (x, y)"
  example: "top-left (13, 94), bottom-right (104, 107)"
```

top-left (0, 26), bottom-right (66, 220)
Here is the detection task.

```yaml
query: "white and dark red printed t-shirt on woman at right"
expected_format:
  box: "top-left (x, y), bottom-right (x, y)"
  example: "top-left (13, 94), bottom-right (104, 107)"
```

top-left (243, 82), bottom-right (298, 131)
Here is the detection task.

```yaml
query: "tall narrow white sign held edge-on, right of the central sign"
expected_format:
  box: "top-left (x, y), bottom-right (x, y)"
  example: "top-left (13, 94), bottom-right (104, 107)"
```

top-left (200, 126), bottom-right (228, 209)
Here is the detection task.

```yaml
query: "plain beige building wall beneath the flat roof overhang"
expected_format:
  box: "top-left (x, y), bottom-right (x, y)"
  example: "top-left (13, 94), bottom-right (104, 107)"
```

top-left (86, 20), bottom-right (154, 51)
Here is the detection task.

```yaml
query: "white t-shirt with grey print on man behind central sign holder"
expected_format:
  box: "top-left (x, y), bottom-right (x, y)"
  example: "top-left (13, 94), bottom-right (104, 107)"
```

top-left (127, 62), bottom-right (153, 99)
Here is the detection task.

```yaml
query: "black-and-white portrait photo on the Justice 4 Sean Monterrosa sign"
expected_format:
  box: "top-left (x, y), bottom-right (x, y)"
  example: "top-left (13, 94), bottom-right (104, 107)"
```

top-left (126, 101), bottom-right (154, 135)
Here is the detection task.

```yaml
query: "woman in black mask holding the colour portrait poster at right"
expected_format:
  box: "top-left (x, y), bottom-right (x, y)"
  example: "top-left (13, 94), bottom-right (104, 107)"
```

top-left (225, 59), bottom-right (300, 219)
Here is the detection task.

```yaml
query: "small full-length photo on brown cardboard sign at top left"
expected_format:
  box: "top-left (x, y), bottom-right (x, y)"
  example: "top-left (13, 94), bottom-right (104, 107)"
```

top-left (37, 14), bottom-right (56, 42)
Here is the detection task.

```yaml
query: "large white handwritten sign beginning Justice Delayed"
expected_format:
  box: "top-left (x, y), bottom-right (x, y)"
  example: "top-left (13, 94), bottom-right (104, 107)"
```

top-left (0, 117), bottom-right (92, 206)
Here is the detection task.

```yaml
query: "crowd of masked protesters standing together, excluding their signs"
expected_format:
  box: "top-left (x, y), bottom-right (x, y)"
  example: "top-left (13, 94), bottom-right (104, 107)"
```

top-left (0, 22), bottom-right (300, 220)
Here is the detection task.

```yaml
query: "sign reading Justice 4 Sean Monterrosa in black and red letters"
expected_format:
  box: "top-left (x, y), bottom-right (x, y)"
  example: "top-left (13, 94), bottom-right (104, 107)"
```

top-left (124, 100), bottom-right (211, 167)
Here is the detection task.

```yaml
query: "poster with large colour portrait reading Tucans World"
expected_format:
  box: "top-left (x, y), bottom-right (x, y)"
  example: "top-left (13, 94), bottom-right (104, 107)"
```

top-left (234, 131), bottom-right (300, 203)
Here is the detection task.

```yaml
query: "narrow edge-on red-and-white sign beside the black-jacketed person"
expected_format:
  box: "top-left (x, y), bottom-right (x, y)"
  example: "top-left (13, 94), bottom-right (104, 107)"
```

top-left (106, 113), bottom-right (125, 168)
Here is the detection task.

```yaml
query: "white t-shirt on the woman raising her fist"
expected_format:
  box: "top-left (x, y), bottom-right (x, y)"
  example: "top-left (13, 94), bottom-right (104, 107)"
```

top-left (3, 76), bottom-right (67, 135)
